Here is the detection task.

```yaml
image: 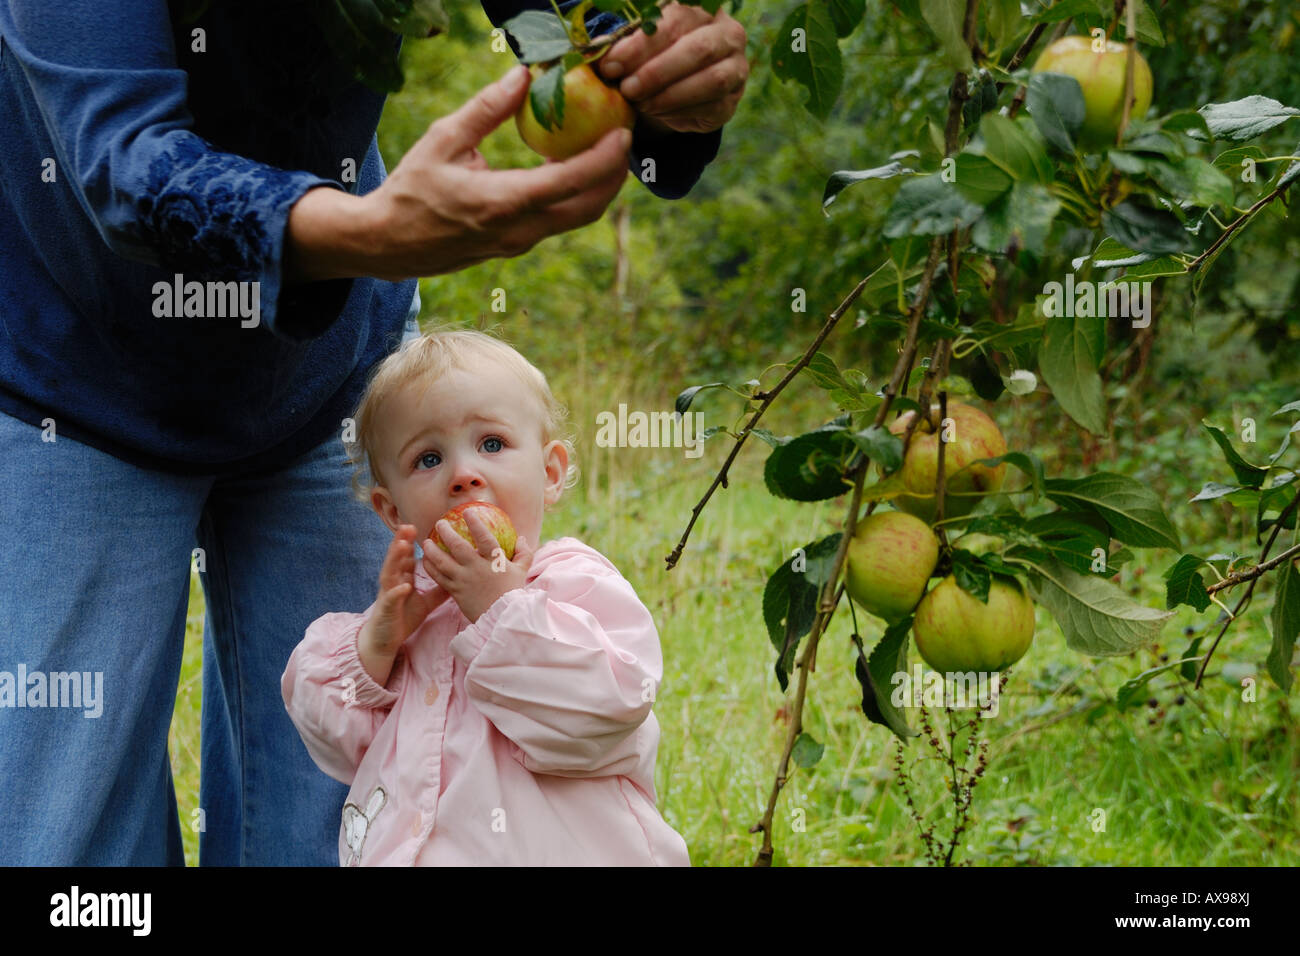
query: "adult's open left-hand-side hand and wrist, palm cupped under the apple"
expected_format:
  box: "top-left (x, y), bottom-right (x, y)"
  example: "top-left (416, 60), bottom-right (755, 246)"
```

top-left (287, 65), bottom-right (632, 281)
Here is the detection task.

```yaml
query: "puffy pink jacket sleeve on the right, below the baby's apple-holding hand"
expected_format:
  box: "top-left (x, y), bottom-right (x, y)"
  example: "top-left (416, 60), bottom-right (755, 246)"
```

top-left (451, 553), bottom-right (663, 777)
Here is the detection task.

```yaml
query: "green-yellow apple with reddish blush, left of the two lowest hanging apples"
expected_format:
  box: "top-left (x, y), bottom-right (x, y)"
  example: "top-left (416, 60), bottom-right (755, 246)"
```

top-left (845, 511), bottom-right (939, 620)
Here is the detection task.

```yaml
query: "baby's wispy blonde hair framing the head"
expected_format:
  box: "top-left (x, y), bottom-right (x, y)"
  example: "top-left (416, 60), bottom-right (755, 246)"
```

top-left (347, 329), bottom-right (577, 505)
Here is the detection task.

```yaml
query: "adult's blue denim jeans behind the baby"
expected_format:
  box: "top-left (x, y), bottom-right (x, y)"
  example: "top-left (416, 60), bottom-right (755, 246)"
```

top-left (0, 287), bottom-right (417, 866)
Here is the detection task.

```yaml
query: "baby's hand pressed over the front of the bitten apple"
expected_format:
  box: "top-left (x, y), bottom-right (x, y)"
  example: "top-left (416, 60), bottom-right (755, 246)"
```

top-left (420, 509), bottom-right (533, 620)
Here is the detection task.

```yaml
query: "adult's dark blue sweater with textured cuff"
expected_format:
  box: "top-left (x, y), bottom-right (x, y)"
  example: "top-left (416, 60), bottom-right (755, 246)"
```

top-left (0, 0), bottom-right (722, 473)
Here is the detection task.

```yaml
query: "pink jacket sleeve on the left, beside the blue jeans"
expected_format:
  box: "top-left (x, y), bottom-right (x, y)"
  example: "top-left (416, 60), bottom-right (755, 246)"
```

top-left (280, 610), bottom-right (407, 783)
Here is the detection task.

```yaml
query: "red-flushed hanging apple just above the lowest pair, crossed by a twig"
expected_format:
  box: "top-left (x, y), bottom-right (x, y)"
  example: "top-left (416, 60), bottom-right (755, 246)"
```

top-left (889, 402), bottom-right (1006, 524)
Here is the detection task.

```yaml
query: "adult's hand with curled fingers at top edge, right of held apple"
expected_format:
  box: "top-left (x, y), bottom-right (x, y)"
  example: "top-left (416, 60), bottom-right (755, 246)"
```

top-left (599, 3), bottom-right (749, 133)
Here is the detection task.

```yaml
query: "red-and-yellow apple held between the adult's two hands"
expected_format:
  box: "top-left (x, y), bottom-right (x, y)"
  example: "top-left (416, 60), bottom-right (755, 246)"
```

top-left (515, 64), bottom-right (636, 160)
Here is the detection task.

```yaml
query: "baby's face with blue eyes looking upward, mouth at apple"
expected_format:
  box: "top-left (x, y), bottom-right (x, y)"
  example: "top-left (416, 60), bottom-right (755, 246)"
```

top-left (371, 359), bottom-right (568, 548)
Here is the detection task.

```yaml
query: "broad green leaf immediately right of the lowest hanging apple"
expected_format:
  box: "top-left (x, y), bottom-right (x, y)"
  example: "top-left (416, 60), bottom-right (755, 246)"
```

top-left (1027, 561), bottom-right (1174, 657)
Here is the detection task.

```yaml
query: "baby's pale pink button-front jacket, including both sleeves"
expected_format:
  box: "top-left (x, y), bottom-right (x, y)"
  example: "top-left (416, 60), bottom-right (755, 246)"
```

top-left (281, 537), bottom-right (690, 866)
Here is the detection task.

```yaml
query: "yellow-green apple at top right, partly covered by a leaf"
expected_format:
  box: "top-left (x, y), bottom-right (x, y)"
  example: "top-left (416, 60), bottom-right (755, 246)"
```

top-left (1034, 36), bottom-right (1152, 148)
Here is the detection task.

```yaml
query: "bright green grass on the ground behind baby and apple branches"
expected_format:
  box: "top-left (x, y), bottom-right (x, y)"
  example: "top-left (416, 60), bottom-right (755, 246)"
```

top-left (172, 418), bottom-right (1300, 866)
